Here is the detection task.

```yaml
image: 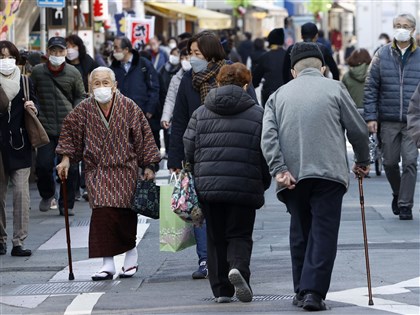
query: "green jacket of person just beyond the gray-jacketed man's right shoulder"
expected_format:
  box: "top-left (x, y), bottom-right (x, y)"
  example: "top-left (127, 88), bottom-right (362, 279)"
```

top-left (341, 63), bottom-right (369, 108)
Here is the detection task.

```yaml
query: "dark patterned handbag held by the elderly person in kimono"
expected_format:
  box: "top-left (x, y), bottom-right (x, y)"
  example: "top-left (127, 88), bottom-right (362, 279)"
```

top-left (131, 178), bottom-right (160, 219)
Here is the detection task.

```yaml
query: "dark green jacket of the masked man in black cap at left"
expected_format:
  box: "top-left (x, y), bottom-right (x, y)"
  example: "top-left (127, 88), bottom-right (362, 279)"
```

top-left (31, 64), bottom-right (85, 136)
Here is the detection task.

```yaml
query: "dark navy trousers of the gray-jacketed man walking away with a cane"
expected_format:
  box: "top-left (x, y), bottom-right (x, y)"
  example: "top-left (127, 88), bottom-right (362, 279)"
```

top-left (282, 179), bottom-right (346, 299)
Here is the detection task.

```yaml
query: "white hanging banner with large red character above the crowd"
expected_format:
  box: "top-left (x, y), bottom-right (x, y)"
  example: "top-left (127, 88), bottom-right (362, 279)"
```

top-left (125, 16), bottom-right (155, 50)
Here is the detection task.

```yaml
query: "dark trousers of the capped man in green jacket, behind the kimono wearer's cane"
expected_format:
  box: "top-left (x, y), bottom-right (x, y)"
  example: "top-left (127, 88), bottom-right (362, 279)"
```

top-left (35, 136), bottom-right (78, 209)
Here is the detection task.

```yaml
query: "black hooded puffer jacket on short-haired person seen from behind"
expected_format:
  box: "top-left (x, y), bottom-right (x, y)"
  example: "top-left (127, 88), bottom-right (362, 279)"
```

top-left (184, 85), bottom-right (271, 209)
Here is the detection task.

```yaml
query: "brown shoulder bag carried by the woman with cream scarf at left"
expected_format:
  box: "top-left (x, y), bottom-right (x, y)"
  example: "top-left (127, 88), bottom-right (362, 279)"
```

top-left (22, 76), bottom-right (50, 148)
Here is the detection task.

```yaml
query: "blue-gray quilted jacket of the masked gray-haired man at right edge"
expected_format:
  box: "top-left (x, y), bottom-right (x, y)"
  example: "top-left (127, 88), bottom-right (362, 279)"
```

top-left (363, 42), bottom-right (420, 122)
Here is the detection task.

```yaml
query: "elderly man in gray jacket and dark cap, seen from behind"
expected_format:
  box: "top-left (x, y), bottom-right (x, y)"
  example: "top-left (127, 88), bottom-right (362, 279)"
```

top-left (261, 42), bottom-right (370, 311)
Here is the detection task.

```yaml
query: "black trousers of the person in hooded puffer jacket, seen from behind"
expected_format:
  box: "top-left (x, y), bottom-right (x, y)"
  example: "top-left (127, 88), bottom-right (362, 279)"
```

top-left (202, 203), bottom-right (255, 297)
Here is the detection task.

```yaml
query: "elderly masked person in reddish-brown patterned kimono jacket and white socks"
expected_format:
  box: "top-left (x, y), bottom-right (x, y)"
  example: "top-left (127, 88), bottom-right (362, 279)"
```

top-left (56, 67), bottom-right (160, 281)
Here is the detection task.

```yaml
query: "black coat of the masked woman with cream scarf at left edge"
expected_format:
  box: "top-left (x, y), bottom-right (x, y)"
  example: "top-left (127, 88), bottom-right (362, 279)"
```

top-left (0, 78), bottom-right (39, 174)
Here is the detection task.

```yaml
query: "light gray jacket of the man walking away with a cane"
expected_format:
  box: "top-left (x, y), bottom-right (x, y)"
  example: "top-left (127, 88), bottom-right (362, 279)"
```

top-left (261, 68), bottom-right (370, 199)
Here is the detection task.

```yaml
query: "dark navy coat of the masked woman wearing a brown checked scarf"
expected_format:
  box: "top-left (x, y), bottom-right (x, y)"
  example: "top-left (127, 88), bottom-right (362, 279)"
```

top-left (168, 61), bottom-right (258, 169)
